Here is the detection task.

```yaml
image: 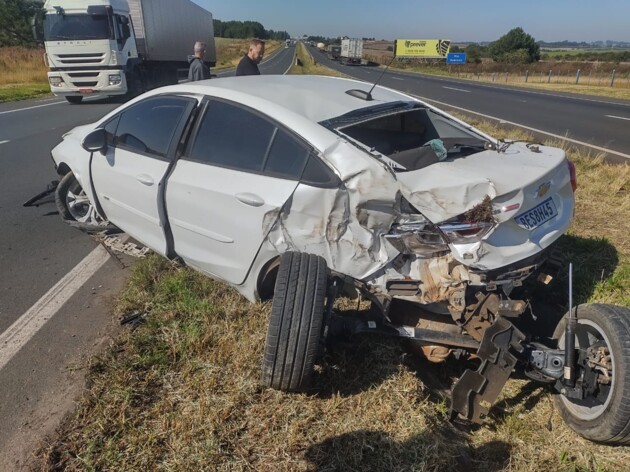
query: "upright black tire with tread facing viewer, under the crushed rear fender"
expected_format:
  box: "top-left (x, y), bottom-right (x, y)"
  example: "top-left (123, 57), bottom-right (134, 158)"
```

top-left (262, 252), bottom-right (328, 392)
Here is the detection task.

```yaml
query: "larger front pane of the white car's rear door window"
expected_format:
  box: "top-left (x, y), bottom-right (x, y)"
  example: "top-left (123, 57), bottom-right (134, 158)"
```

top-left (189, 101), bottom-right (275, 172)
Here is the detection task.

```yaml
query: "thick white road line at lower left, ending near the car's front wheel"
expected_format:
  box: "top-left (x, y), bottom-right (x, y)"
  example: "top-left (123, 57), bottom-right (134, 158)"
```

top-left (0, 246), bottom-right (109, 369)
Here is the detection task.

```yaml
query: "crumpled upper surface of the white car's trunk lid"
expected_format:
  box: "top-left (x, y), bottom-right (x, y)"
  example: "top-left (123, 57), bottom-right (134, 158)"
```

top-left (397, 143), bottom-right (565, 223)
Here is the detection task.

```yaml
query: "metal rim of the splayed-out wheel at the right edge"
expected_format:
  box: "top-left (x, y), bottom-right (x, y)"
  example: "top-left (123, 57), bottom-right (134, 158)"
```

top-left (558, 319), bottom-right (615, 421)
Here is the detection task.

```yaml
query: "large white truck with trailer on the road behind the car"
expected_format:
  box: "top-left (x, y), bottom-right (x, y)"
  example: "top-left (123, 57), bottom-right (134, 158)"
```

top-left (34, 0), bottom-right (216, 103)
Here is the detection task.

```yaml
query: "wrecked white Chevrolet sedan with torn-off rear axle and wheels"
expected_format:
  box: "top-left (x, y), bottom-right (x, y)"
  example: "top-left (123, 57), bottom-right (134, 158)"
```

top-left (52, 76), bottom-right (630, 443)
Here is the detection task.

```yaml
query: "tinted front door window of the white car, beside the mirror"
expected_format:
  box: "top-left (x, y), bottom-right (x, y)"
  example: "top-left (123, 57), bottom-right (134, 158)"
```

top-left (110, 97), bottom-right (189, 158)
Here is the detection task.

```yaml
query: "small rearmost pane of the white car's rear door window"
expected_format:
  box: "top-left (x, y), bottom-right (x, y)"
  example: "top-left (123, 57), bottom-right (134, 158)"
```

top-left (264, 129), bottom-right (309, 180)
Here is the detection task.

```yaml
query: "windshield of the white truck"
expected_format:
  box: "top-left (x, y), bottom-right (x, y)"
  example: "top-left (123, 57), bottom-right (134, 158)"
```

top-left (44, 14), bottom-right (114, 41)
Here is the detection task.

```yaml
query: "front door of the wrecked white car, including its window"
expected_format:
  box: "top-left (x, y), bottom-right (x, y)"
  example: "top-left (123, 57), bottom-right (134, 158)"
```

top-left (91, 96), bottom-right (195, 254)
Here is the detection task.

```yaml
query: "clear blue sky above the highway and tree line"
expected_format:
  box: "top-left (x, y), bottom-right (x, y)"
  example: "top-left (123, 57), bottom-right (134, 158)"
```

top-left (194, 0), bottom-right (630, 42)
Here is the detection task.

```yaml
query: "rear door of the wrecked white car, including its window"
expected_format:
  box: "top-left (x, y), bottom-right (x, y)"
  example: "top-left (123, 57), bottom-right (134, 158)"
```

top-left (166, 100), bottom-right (310, 285)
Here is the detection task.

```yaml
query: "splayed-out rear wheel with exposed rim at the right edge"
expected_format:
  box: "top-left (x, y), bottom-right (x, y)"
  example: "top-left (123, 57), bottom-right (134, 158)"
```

top-left (554, 304), bottom-right (630, 444)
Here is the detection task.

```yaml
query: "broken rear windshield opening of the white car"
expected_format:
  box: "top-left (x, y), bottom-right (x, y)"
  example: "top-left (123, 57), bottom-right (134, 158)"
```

top-left (321, 102), bottom-right (492, 172)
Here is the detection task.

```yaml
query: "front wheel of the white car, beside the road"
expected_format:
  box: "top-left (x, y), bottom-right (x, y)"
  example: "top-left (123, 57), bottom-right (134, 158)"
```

top-left (55, 172), bottom-right (114, 231)
